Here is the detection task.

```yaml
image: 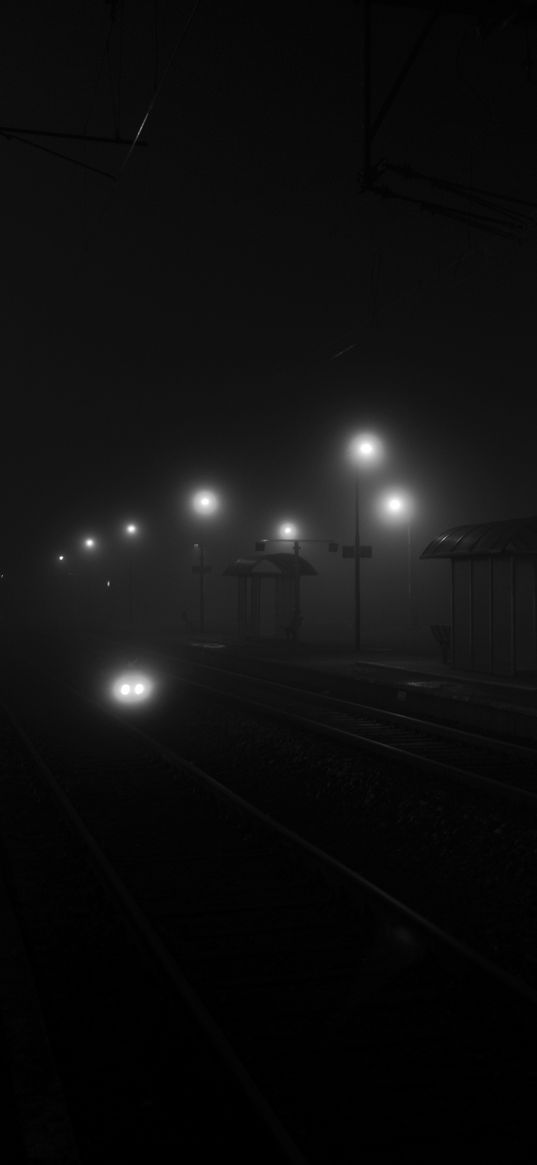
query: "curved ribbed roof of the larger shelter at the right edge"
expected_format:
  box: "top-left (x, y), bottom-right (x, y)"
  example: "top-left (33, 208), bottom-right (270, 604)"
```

top-left (419, 517), bottom-right (537, 558)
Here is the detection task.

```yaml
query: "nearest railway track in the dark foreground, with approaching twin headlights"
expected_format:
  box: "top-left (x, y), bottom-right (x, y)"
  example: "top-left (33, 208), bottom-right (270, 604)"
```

top-left (2, 643), bottom-right (537, 1165)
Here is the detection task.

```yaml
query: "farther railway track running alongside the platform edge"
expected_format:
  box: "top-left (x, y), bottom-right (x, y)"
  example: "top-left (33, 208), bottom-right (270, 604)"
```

top-left (169, 657), bottom-right (537, 807)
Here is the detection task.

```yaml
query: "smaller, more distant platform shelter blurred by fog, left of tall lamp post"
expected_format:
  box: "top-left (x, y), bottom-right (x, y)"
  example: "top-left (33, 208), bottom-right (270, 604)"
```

top-left (224, 553), bottom-right (317, 640)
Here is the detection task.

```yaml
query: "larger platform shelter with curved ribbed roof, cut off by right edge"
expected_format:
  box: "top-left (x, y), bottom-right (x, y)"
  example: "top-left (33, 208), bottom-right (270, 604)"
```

top-left (419, 517), bottom-right (537, 676)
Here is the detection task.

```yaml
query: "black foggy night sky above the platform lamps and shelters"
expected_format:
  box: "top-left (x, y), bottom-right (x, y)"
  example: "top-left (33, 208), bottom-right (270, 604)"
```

top-left (0, 0), bottom-right (537, 629)
